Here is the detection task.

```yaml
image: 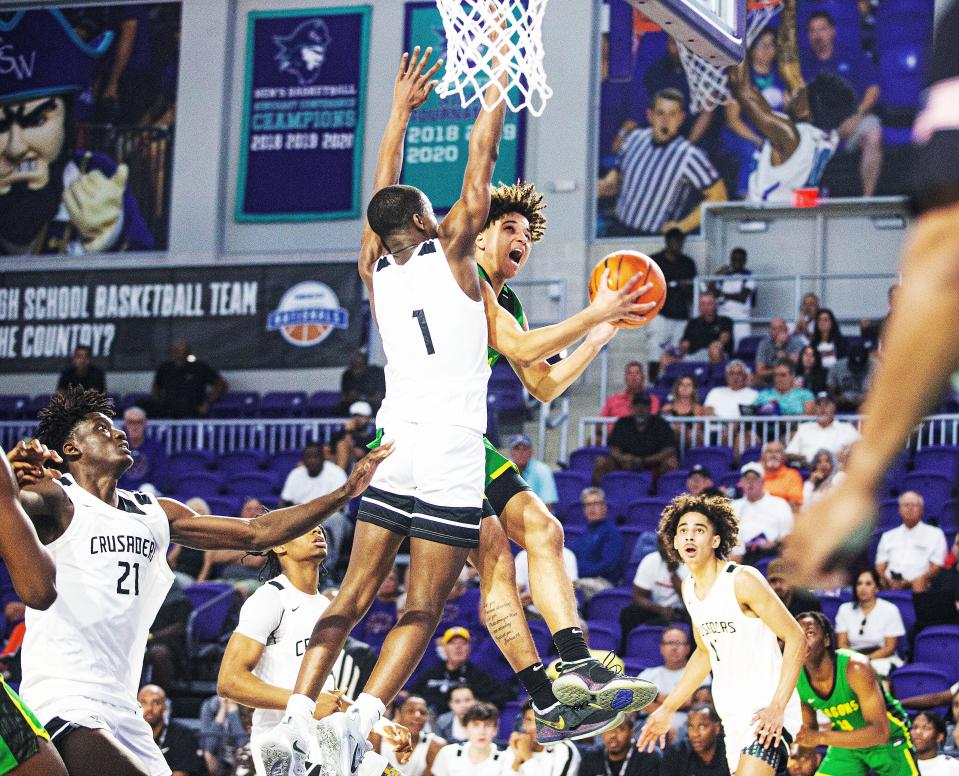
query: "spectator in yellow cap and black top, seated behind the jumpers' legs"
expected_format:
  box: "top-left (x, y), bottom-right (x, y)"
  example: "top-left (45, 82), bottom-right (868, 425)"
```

top-left (410, 626), bottom-right (516, 716)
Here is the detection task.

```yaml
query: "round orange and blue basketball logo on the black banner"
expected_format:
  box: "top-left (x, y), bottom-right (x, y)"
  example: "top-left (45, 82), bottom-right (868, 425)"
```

top-left (266, 280), bottom-right (350, 348)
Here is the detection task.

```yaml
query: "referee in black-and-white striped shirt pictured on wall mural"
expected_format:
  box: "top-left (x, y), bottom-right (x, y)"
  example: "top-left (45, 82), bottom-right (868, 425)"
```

top-left (597, 89), bottom-right (727, 235)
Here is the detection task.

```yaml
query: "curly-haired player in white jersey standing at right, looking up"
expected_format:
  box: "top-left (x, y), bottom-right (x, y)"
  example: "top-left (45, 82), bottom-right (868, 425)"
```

top-left (637, 495), bottom-right (806, 776)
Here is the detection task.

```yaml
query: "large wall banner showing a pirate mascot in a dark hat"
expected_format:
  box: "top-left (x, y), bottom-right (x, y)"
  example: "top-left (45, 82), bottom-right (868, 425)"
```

top-left (0, 2), bottom-right (181, 256)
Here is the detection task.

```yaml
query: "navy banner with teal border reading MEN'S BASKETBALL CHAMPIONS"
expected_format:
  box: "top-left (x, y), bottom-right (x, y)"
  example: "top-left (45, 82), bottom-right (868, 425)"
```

top-left (236, 6), bottom-right (370, 221)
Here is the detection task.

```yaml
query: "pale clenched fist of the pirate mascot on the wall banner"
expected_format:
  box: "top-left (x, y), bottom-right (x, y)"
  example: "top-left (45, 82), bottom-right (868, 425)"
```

top-left (63, 164), bottom-right (129, 253)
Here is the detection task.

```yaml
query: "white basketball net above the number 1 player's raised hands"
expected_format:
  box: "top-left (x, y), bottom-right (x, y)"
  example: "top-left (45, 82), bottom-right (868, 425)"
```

top-left (436, 0), bottom-right (553, 116)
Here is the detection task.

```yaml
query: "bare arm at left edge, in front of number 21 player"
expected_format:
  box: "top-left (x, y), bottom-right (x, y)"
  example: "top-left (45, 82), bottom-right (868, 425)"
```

top-left (0, 450), bottom-right (58, 609)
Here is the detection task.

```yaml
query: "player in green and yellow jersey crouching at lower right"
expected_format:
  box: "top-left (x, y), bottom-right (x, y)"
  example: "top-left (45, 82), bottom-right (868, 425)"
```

top-left (796, 612), bottom-right (919, 776)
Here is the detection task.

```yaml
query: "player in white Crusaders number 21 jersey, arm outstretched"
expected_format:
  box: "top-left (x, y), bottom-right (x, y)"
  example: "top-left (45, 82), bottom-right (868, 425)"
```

top-left (7, 386), bottom-right (391, 776)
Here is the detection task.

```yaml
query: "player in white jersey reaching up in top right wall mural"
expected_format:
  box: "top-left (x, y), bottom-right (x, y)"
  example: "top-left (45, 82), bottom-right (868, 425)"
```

top-left (728, 0), bottom-right (856, 204)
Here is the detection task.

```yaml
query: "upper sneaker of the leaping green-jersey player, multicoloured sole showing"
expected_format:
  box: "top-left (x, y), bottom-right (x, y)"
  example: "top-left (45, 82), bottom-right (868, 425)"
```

top-left (553, 658), bottom-right (658, 713)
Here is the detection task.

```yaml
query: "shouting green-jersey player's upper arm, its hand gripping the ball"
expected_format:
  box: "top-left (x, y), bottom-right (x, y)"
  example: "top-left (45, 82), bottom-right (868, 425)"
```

top-left (480, 270), bottom-right (656, 366)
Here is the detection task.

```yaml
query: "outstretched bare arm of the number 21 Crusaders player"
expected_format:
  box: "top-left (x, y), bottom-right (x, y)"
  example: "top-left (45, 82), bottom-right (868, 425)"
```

top-left (160, 442), bottom-right (394, 552)
